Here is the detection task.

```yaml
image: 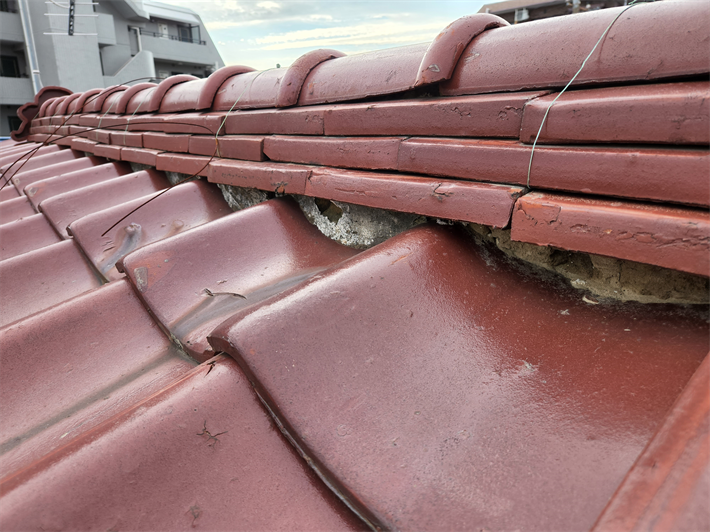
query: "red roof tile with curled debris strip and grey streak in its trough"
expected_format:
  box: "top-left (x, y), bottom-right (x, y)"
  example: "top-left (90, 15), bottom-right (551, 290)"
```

top-left (118, 199), bottom-right (355, 361)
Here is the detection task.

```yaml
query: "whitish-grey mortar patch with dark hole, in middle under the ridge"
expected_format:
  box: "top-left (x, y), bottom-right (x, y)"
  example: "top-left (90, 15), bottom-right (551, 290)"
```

top-left (293, 196), bottom-right (426, 249)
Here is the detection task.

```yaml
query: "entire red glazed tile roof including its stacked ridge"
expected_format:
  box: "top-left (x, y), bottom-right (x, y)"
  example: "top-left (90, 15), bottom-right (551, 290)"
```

top-left (0, 2), bottom-right (710, 532)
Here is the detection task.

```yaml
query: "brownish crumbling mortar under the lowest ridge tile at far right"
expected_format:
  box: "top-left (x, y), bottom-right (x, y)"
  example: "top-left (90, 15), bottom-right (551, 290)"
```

top-left (467, 224), bottom-right (710, 304)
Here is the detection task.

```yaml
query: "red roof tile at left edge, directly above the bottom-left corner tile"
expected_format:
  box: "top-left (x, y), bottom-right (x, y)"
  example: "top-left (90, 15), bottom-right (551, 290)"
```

top-left (0, 281), bottom-right (195, 480)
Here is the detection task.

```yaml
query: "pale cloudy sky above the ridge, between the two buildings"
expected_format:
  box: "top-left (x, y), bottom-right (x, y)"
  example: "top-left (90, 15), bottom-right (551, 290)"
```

top-left (160, 0), bottom-right (493, 70)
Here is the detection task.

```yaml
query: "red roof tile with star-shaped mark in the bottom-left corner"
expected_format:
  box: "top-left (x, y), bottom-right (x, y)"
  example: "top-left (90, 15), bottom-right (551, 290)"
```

top-left (0, 357), bottom-right (372, 532)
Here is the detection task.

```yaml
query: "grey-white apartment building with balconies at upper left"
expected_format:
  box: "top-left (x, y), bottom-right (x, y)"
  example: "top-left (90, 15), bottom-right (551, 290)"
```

top-left (0, 0), bottom-right (224, 136)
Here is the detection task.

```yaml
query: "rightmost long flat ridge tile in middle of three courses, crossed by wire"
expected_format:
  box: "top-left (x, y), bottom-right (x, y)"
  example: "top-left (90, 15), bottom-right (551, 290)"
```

top-left (398, 138), bottom-right (710, 206)
